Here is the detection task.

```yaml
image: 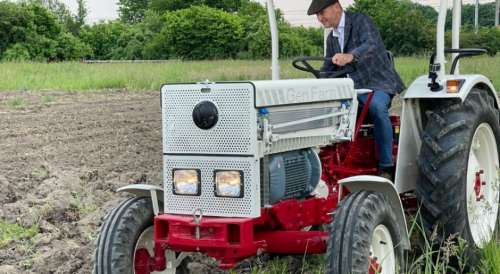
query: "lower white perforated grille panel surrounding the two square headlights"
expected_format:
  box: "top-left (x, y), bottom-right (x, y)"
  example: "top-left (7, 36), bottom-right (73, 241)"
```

top-left (163, 155), bottom-right (260, 217)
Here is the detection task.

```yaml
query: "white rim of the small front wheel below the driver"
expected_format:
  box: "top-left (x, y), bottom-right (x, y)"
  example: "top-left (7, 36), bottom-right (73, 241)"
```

top-left (370, 224), bottom-right (396, 274)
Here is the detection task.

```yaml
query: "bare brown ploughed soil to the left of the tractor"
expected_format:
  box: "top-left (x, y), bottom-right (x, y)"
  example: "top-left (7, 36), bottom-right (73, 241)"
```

top-left (0, 92), bottom-right (166, 274)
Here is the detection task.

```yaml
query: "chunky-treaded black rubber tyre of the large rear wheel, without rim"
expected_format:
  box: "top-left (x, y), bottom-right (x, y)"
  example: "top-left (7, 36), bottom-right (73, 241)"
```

top-left (416, 89), bottom-right (500, 263)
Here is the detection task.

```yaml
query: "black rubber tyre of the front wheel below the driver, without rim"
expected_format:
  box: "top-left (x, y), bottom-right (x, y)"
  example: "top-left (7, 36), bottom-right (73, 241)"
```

top-left (326, 191), bottom-right (405, 274)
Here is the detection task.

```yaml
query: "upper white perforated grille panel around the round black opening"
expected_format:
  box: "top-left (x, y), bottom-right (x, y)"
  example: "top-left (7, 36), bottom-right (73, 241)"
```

top-left (162, 83), bottom-right (257, 155)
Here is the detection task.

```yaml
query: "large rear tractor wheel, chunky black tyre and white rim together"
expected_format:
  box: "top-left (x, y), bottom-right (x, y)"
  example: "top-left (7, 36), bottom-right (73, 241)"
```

top-left (417, 89), bottom-right (500, 263)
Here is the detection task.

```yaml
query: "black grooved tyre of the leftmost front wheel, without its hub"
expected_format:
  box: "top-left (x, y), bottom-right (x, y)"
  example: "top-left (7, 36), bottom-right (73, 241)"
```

top-left (93, 197), bottom-right (188, 274)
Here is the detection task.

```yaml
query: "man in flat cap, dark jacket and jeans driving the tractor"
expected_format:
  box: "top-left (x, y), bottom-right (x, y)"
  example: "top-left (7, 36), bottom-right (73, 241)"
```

top-left (307, 0), bottom-right (405, 180)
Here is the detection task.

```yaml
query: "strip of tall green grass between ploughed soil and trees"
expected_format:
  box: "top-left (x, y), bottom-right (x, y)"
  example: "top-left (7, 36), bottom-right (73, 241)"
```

top-left (0, 56), bottom-right (500, 91)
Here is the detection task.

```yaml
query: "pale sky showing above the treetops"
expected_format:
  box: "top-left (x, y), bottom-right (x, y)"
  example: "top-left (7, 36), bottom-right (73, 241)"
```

top-left (61, 0), bottom-right (494, 26)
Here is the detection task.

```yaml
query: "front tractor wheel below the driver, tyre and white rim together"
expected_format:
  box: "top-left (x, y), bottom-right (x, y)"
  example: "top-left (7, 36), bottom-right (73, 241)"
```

top-left (326, 191), bottom-right (404, 274)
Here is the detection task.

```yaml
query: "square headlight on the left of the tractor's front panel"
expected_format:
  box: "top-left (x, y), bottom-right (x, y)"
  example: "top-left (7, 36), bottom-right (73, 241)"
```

top-left (172, 169), bottom-right (201, 196)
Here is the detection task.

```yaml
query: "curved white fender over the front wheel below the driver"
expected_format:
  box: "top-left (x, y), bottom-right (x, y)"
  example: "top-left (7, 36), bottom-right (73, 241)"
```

top-left (339, 175), bottom-right (411, 250)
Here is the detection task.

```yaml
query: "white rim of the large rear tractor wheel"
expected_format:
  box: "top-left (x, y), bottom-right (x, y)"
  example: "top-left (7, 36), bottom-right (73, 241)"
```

top-left (466, 123), bottom-right (499, 248)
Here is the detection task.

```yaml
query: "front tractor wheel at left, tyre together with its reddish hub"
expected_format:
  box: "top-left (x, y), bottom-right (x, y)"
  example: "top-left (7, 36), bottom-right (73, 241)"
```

top-left (94, 197), bottom-right (186, 274)
